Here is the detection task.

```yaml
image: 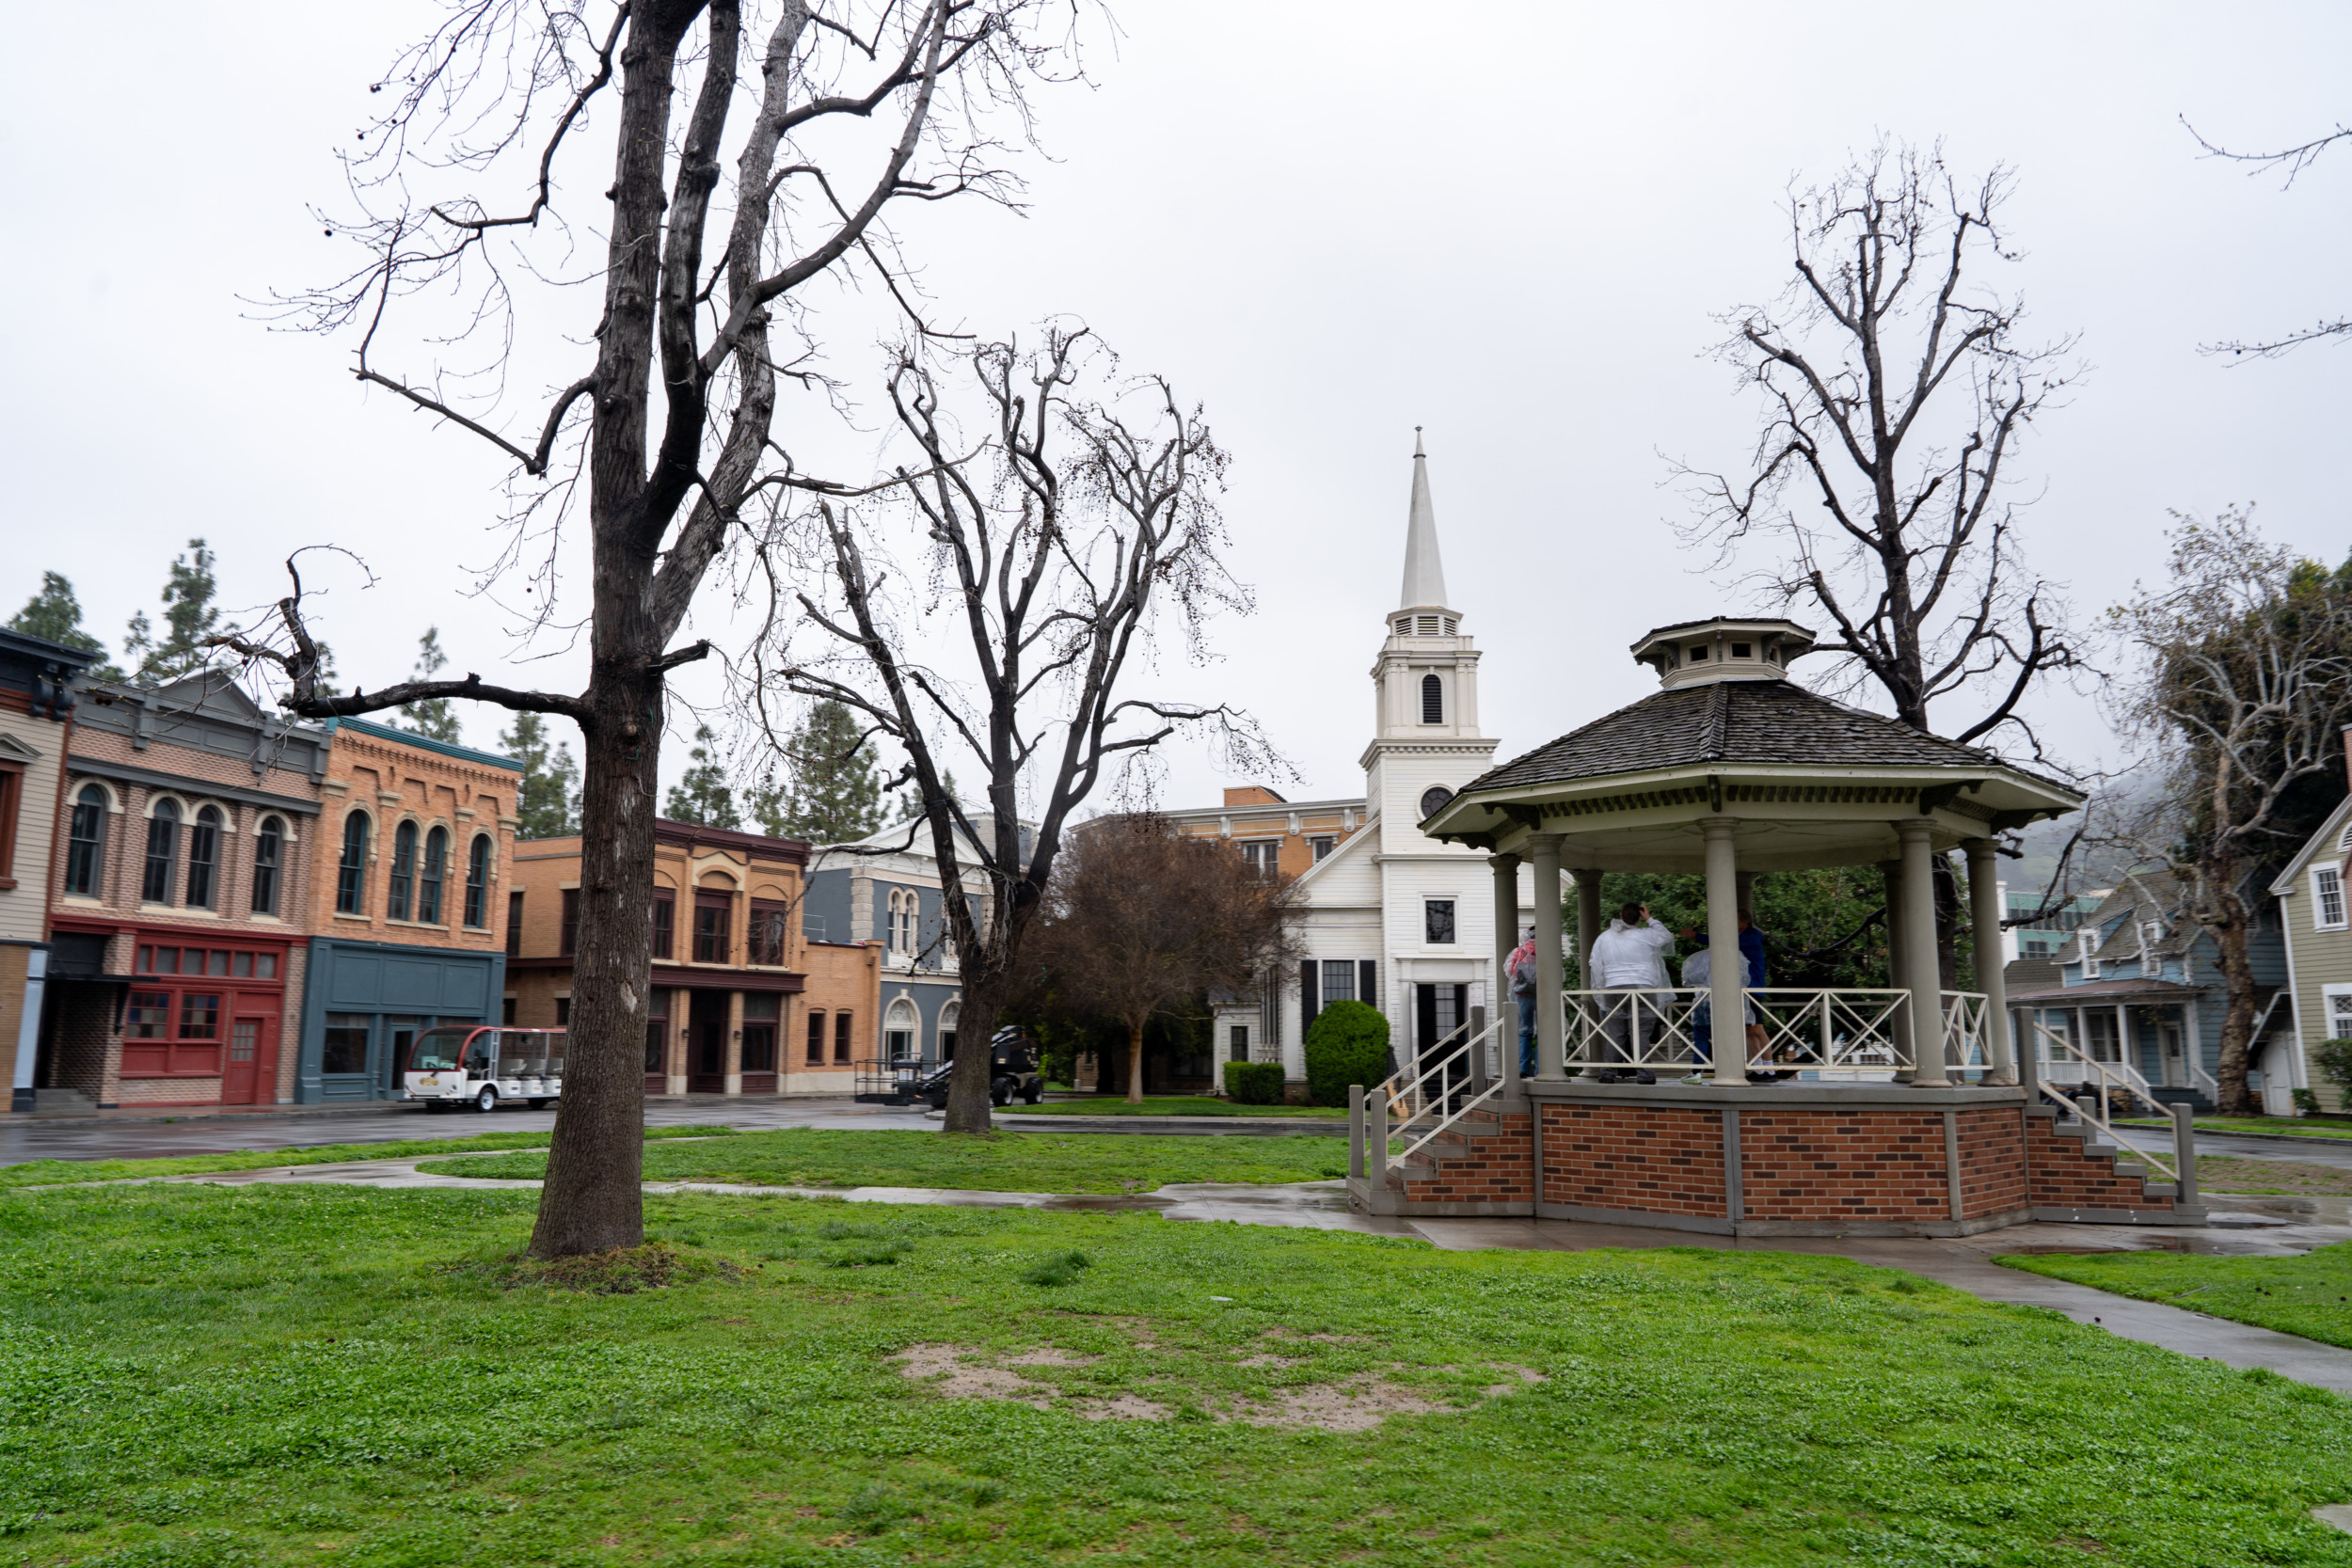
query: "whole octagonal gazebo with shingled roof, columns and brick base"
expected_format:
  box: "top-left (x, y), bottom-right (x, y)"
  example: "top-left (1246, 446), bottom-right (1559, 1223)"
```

top-left (1350, 618), bottom-right (2204, 1234)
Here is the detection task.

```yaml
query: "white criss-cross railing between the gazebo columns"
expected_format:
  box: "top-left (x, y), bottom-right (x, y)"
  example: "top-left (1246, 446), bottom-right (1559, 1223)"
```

top-left (1562, 985), bottom-right (1990, 1082)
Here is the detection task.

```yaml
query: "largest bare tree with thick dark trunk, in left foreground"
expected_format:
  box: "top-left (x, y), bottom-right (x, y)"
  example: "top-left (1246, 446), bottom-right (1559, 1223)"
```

top-left (212, 0), bottom-right (1077, 1256)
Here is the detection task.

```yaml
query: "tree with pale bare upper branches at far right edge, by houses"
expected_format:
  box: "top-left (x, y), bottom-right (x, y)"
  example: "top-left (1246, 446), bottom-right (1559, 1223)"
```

top-left (2110, 510), bottom-right (2352, 1115)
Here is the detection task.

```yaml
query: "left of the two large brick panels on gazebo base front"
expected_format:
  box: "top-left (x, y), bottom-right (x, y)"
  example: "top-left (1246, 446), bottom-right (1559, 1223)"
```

top-left (1543, 1105), bottom-right (1724, 1220)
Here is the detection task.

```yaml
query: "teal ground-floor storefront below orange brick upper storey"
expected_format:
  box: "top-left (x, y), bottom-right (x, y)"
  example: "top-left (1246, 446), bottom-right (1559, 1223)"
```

top-left (294, 936), bottom-right (506, 1105)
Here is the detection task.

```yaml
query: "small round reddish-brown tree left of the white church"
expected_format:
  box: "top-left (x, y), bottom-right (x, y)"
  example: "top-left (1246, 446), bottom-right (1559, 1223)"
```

top-left (1035, 814), bottom-right (1298, 1105)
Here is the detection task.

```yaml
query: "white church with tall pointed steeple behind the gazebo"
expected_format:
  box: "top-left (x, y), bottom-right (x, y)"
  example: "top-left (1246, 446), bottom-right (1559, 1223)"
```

top-left (1167, 439), bottom-right (1566, 1079)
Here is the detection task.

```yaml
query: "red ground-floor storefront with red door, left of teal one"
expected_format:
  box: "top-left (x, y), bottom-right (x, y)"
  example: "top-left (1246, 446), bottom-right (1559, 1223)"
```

top-left (56, 922), bottom-right (290, 1105)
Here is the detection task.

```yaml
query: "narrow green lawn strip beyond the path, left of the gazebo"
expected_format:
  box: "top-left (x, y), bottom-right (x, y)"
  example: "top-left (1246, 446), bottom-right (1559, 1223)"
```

top-left (423, 1126), bottom-right (1348, 1192)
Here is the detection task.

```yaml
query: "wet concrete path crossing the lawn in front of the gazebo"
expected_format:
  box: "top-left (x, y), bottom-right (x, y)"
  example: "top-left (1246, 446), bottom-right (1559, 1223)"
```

top-left (128, 1157), bottom-right (2352, 1394)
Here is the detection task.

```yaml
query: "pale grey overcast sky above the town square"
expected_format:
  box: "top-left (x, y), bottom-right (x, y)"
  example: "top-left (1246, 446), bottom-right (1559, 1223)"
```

top-left (0, 0), bottom-right (2352, 804)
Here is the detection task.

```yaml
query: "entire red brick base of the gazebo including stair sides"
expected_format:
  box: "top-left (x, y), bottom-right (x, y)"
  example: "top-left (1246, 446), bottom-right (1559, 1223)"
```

top-left (1348, 1079), bottom-right (2206, 1237)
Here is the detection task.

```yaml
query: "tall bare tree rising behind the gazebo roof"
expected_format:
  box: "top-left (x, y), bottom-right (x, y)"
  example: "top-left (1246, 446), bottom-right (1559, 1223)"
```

top-left (1677, 143), bottom-right (2079, 754)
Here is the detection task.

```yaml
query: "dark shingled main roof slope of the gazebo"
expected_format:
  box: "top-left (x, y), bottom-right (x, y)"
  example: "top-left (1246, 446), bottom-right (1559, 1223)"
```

top-left (1463, 679), bottom-right (2065, 795)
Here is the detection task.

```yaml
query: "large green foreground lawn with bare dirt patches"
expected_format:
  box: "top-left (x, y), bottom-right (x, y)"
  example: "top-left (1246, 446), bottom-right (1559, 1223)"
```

top-left (0, 1187), bottom-right (2352, 1568)
